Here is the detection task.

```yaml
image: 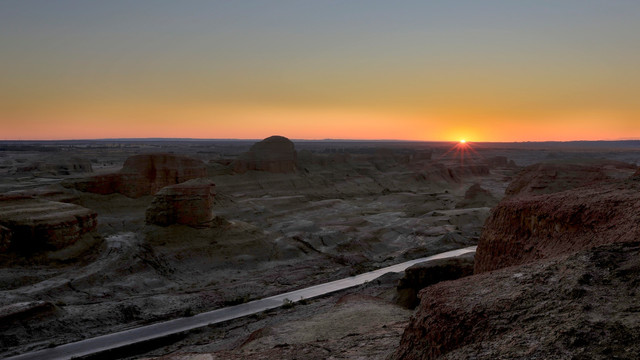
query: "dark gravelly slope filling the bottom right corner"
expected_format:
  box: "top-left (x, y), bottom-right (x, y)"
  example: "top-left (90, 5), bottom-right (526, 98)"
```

top-left (392, 241), bottom-right (640, 359)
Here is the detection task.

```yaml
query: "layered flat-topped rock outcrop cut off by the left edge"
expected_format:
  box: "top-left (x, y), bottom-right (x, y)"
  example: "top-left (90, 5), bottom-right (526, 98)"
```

top-left (0, 196), bottom-right (97, 253)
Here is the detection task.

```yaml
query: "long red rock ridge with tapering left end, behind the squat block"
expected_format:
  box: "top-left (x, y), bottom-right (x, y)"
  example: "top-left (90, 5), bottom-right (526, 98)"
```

top-left (66, 154), bottom-right (207, 198)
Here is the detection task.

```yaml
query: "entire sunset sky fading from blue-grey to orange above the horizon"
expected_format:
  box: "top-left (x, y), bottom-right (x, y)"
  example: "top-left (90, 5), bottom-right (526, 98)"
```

top-left (0, 0), bottom-right (640, 141)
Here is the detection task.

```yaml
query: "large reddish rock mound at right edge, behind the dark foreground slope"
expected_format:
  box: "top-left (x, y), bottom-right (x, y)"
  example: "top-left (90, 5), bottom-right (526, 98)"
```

top-left (475, 181), bottom-right (640, 273)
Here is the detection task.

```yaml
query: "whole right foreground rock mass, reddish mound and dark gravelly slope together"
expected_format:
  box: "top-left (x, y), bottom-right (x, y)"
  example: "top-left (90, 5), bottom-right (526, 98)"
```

top-left (393, 168), bottom-right (640, 359)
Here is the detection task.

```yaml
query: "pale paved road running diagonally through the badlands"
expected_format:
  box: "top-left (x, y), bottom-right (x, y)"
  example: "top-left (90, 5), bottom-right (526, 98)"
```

top-left (5, 246), bottom-right (476, 360)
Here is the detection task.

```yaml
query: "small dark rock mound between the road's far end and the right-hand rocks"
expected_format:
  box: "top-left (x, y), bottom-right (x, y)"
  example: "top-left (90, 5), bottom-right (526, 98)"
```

top-left (395, 253), bottom-right (474, 309)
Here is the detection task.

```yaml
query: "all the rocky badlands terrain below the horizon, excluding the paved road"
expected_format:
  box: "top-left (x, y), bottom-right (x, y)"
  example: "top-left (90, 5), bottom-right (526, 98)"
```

top-left (0, 136), bottom-right (640, 359)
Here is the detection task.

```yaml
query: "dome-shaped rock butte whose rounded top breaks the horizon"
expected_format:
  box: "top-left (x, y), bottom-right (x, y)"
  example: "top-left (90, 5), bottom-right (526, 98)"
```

top-left (234, 135), bottom-right (296, 173)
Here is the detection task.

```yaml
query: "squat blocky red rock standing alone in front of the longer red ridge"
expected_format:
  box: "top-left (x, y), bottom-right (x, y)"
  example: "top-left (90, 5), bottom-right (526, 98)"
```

top-left (146, 179), bottom-right (215, 227)
